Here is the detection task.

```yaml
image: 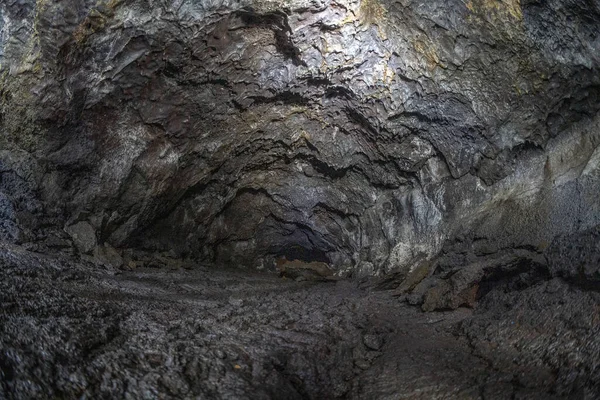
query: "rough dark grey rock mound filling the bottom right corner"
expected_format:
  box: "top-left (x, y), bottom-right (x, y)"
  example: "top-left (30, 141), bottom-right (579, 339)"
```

top-left (460, 279), bottom-right (600, 399)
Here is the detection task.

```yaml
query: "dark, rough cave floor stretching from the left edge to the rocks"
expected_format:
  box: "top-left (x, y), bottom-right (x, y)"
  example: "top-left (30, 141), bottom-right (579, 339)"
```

top-left (0, 247), bottom-right (596, 399)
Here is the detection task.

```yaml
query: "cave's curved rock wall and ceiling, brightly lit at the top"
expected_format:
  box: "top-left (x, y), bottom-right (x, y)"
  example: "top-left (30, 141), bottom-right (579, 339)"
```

top-left (0, 0), bottom-right (600, 282)
